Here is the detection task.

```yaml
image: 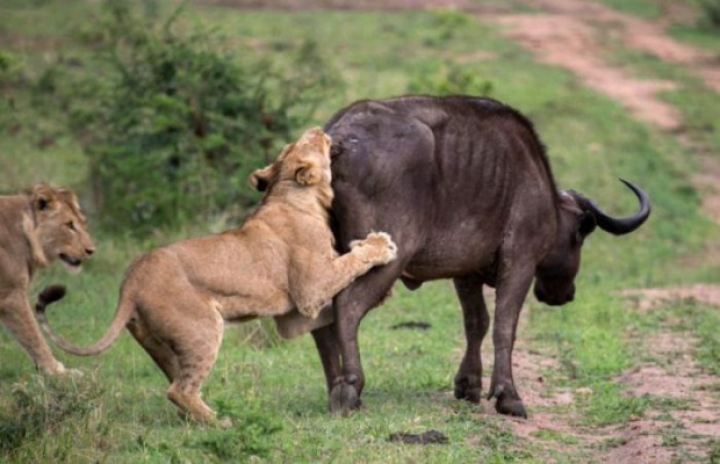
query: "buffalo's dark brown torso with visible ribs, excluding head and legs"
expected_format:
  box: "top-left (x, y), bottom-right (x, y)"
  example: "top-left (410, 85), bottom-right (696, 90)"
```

top-left (325, 96), bottom-right (555, 281)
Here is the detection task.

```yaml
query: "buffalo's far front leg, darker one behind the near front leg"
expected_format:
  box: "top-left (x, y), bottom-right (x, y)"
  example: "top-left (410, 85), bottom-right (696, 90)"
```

top-left (453, 275), bottom-right (490, 403)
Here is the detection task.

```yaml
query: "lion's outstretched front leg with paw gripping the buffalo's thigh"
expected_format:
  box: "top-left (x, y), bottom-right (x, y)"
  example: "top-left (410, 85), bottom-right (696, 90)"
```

top-left (291, 232), bottom-right (397, 319)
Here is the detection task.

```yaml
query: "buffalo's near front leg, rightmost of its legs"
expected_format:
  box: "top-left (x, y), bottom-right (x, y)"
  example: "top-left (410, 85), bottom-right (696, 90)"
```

top-left (488, 262), bottom-right (533, 418)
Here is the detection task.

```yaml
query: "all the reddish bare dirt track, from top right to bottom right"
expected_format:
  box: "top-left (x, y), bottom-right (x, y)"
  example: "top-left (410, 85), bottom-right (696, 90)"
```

top-left (211, 0), bottom-right (720, 458)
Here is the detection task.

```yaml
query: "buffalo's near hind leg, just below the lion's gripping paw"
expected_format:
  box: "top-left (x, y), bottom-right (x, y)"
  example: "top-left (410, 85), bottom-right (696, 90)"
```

top-left (330, 261), bottom-right (404, 414)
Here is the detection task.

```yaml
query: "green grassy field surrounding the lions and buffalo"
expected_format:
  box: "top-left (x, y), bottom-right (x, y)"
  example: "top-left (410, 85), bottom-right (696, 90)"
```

top-left (0, 0), bottom-right (720, 463)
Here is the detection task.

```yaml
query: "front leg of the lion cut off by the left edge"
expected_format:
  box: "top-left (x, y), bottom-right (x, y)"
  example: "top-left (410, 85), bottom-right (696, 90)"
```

top-left (0, 295), bottom-right (68, 375)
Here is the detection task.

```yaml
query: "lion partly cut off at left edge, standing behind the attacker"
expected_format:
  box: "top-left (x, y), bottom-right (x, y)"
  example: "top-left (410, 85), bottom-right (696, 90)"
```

top-left (0, 183), bottom-right (95, 375)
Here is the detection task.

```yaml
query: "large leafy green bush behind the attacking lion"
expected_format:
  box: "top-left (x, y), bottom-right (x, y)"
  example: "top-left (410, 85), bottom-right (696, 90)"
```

top-left (36, 2), bottom-right (338, 234)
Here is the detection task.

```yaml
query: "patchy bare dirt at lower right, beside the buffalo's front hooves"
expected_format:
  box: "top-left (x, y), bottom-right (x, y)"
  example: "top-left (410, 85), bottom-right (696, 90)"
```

top-left (496, 316), bottom-right (720, 464)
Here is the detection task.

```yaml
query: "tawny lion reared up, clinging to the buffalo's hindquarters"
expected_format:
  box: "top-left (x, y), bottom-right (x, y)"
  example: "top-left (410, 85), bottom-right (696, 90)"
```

top-left (36, 127), bottom-right (397, 425)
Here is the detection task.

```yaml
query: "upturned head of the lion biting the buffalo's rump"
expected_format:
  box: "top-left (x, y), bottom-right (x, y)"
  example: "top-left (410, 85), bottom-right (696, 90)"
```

top-left (250, 127), bottom-right (332, 192)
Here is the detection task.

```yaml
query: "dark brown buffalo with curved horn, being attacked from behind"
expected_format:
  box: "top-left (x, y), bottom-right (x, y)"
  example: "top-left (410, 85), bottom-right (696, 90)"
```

top-left (313, 96), bottom-right (650, 417)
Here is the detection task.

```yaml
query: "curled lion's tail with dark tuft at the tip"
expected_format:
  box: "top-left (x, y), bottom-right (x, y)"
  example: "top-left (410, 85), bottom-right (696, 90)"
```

top-left (35, 285), bottom-right (135, 356)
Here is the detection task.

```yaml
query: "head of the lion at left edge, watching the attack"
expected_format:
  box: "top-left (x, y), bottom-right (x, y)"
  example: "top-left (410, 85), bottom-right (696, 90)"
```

top-left (23, 184), bottom-right (95, 272)
